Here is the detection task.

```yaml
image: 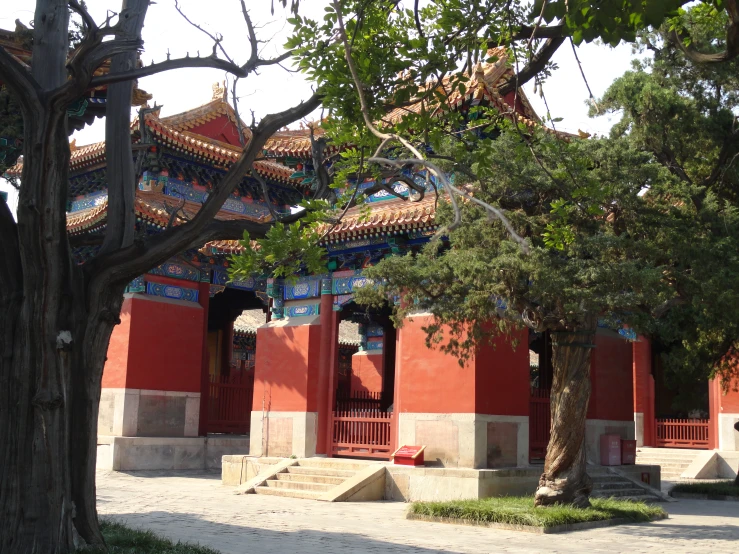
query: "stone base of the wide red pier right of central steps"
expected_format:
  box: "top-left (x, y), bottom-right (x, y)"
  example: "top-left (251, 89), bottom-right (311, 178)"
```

top-left (398, 413), bottom-right (529, 469)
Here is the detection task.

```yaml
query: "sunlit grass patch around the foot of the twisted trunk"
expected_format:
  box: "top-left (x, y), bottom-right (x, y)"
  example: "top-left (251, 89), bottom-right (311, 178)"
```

top-left (410, 496), bottom-right (665, 528)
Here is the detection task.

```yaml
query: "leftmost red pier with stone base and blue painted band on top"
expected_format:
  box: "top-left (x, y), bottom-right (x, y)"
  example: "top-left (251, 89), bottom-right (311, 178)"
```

top-left (98, 275), bottom-right (207, 437)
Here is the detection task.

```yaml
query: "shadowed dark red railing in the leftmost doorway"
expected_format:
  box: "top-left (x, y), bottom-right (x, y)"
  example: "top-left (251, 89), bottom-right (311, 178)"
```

top-left (208, 370), bottom-right (254, 435)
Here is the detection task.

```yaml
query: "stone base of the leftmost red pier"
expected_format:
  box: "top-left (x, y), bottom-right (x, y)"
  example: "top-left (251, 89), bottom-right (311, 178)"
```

top-left (98, 388), bottom-right (200, 437)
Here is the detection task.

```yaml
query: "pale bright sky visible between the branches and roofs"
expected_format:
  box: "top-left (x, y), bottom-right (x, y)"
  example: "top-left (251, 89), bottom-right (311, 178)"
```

top-left (0, 0), bottom-right (632, 215)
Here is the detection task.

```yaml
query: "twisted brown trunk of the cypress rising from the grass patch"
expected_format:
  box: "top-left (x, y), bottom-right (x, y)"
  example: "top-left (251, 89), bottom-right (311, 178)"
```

top-left (534, 323), bottom-right (595, 508)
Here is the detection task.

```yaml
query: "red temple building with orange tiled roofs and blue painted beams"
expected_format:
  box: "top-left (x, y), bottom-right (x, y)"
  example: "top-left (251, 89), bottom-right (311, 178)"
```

top-left (2, 36), bottom-right (739, 484)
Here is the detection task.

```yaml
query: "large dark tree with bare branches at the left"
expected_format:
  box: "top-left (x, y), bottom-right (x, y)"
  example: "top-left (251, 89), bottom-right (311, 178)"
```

top-left (0, 0), bottom-right (320, 554)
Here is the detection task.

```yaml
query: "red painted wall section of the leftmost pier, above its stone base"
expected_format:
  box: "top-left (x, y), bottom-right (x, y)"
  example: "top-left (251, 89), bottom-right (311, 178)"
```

top-left (103, 296), bottom-right (204, 392)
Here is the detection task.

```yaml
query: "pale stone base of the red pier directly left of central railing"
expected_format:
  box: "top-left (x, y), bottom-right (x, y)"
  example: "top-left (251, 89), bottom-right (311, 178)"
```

top-left (249, 410), bottom-right (318, 458)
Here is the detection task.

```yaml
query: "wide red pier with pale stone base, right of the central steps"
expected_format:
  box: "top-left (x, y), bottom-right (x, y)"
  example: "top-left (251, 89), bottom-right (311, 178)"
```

top-left (394, 314), bottom-right (530, 468)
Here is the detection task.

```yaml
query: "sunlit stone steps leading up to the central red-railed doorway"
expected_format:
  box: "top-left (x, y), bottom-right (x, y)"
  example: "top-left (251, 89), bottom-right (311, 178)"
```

top-left (254, 458), bottom-right (372, 500)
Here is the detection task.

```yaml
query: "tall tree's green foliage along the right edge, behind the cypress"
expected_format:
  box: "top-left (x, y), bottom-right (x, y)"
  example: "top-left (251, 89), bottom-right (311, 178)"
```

top-left (598, 8), bottom-right (739, 388)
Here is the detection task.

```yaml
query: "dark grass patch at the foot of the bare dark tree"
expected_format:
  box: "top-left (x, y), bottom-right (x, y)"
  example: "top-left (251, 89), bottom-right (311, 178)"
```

top-left (83, 520), bottom-right (219, 554)
